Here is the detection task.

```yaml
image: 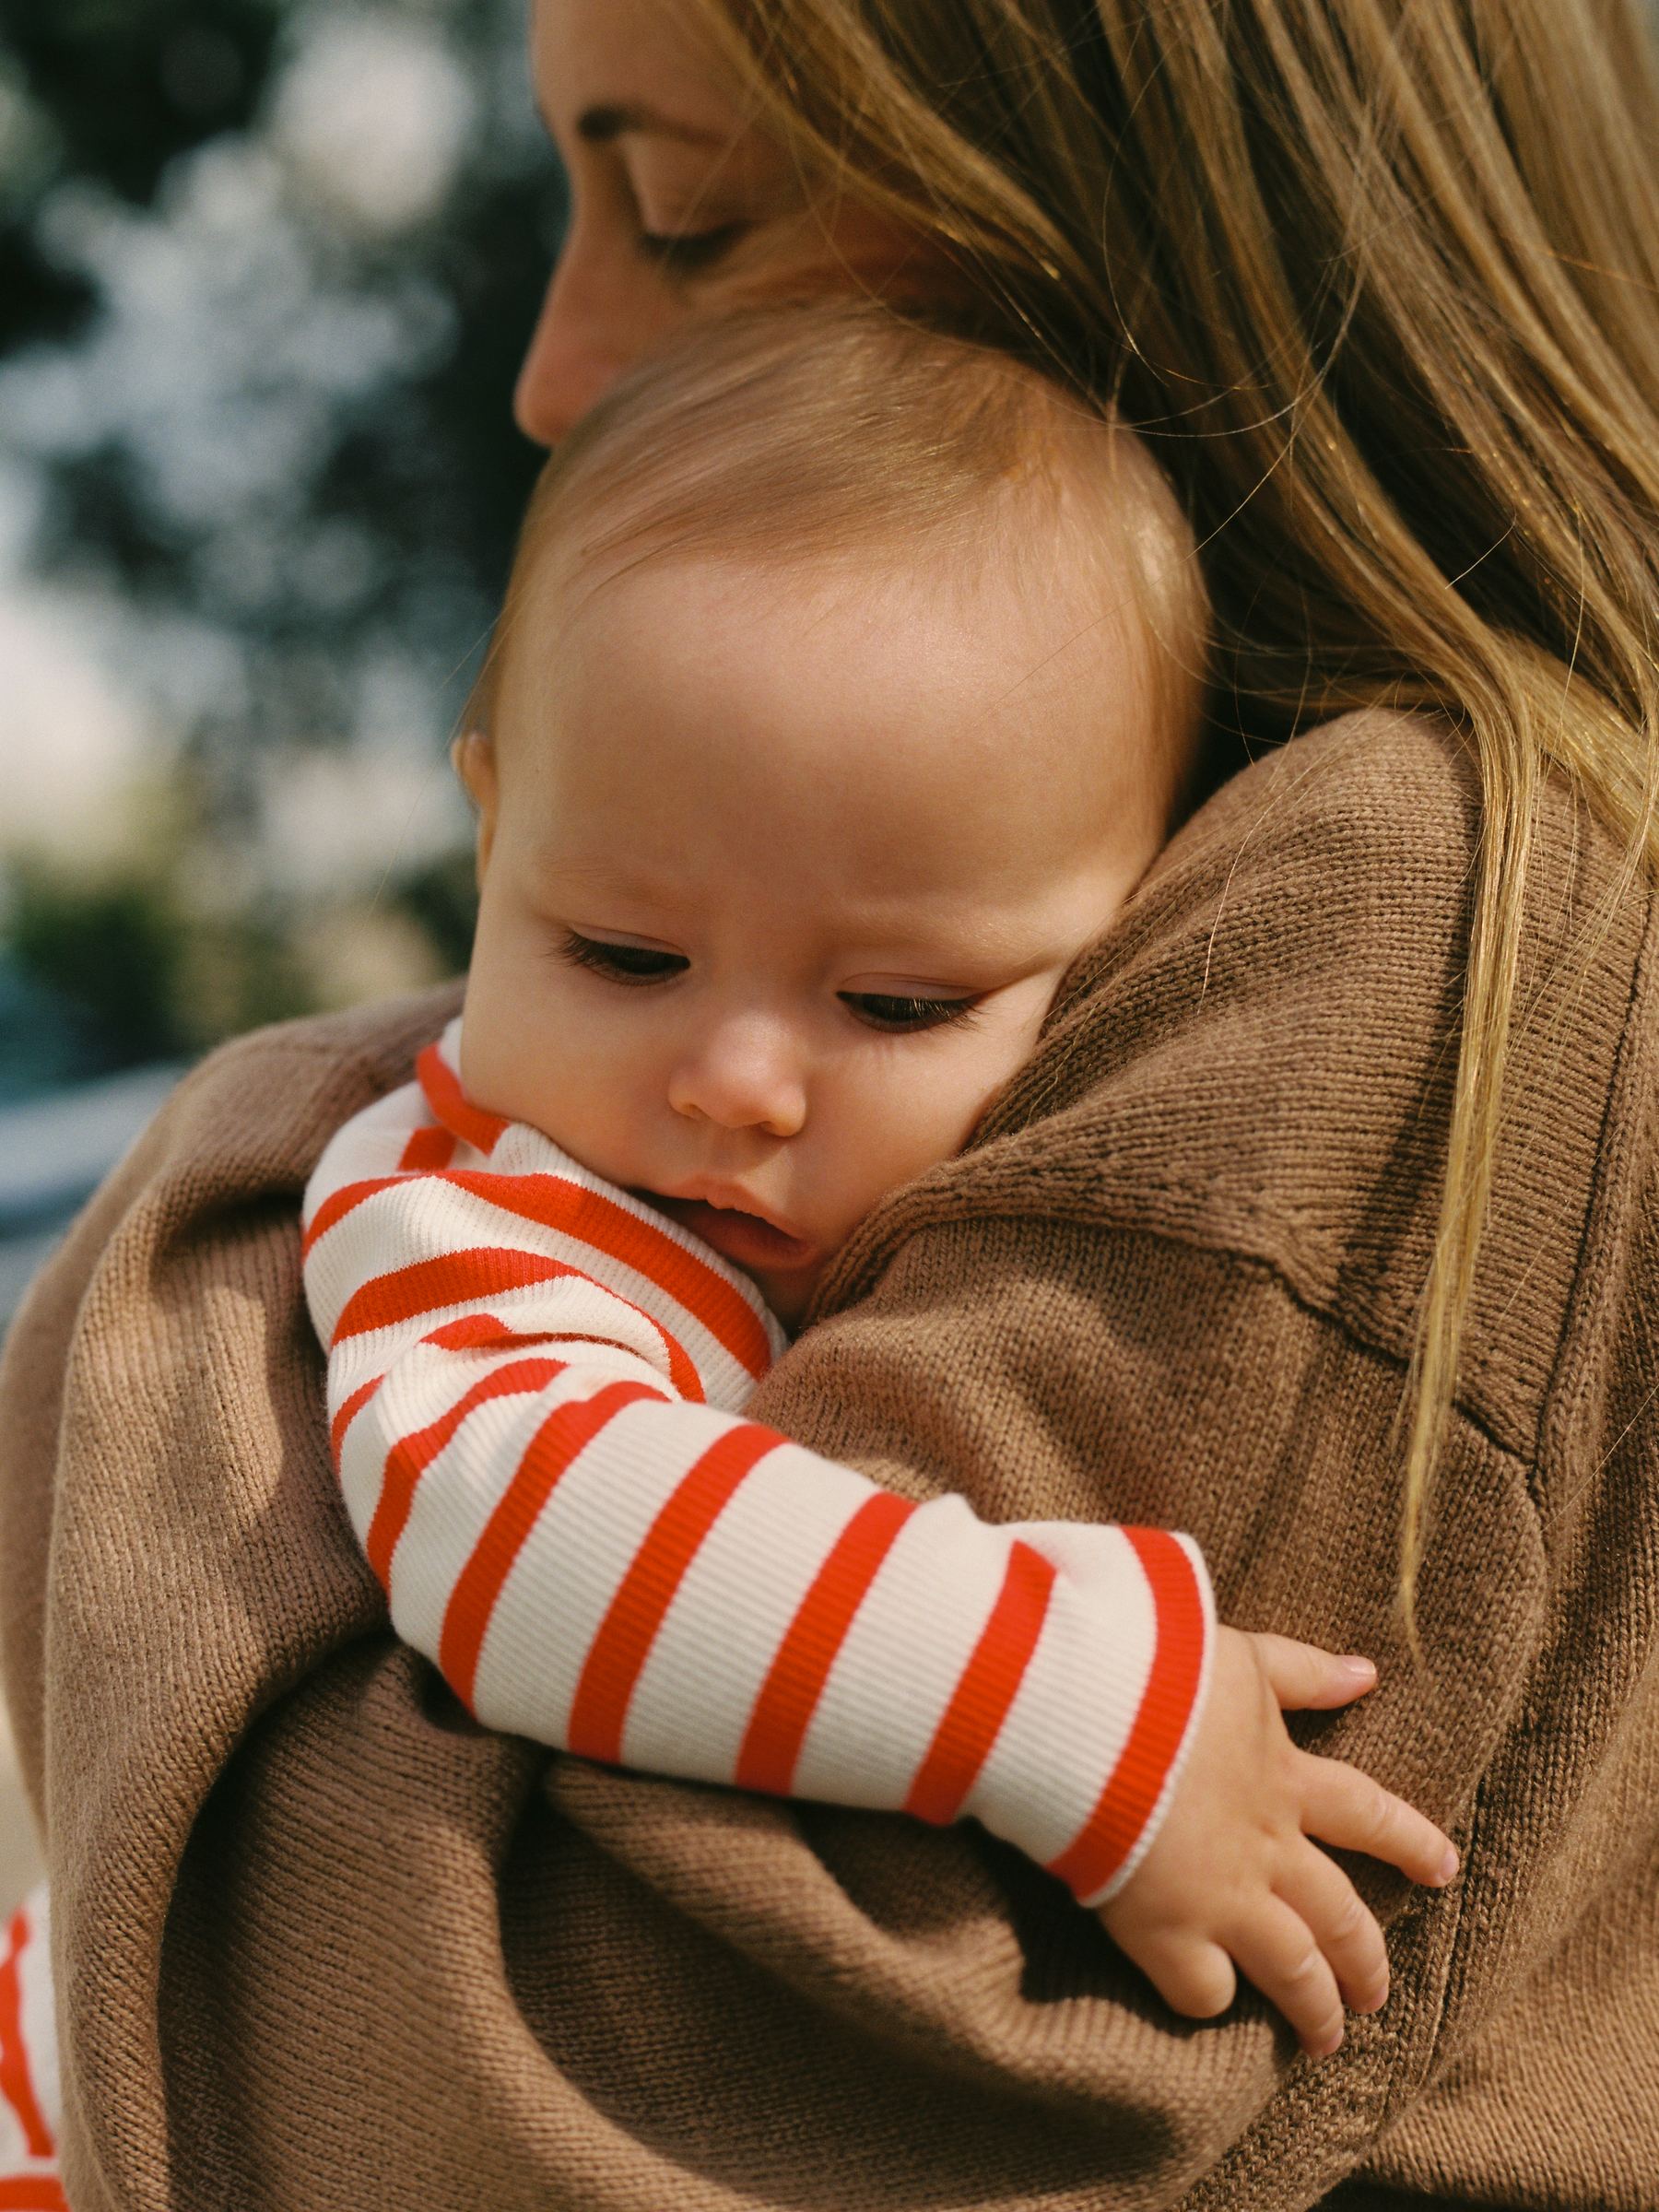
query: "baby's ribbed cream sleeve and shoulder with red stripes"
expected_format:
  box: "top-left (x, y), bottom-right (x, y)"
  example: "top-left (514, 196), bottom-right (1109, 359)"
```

top-left (305, 1024), bottom-right (1212, 1904)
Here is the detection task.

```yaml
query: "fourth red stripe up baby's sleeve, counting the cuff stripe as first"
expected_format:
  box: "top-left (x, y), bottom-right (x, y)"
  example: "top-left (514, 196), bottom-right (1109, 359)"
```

top-left (569, 1420), bottom-right (783, 1765)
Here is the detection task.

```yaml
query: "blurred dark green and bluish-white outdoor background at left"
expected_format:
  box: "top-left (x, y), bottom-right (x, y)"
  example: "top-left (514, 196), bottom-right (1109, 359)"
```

top-left (0, 0), bottom-right (564, 1325)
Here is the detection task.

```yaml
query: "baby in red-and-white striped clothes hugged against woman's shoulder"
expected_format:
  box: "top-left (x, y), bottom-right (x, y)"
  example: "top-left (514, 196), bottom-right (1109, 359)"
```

top-left (0, 308), bottom-right (1455, 2179)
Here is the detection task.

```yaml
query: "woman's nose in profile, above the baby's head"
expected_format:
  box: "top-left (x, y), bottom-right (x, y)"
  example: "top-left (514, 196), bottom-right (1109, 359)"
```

top-left (513, 215), bottom-right (684, 444)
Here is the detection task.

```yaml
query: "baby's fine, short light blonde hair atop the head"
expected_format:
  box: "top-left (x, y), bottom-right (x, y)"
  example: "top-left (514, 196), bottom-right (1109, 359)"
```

top-left (466, 300), bottom-right (1206, 818)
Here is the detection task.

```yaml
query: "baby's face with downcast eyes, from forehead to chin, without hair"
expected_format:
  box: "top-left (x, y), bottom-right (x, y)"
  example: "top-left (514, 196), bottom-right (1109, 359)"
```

top-left (463, 559), bottom-right (1168, 1323)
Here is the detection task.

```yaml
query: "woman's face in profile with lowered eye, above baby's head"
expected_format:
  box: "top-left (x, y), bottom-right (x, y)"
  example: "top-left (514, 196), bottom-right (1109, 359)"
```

top-left (513, 0), bottom-right (942, 444)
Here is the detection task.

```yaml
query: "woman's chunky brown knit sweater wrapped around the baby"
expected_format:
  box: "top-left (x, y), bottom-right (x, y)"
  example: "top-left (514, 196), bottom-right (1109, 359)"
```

top-left (0, 719), bottom-right (1659, 2212)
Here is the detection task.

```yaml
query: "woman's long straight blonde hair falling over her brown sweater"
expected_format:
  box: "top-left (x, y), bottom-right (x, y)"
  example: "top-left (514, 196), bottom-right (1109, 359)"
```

top-left (695, 0), bottom-right (1659, 1643)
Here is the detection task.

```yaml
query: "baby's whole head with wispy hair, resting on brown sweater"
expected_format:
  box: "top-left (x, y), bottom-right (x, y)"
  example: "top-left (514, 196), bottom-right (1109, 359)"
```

top-left (458, 305), bottom-right (1204, 1321)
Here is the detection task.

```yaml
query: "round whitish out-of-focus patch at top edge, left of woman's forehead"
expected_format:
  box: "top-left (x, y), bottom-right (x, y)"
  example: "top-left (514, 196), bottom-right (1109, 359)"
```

top-left (270, 11), bottom-right (476, 232)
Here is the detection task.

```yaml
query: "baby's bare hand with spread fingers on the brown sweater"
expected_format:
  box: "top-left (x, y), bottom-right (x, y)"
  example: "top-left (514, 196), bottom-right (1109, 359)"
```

top-left (1100, 1628), bottom-right (1458, 2057)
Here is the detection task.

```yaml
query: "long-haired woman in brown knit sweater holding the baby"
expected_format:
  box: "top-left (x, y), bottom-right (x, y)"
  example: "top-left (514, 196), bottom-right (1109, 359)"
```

top-left (0, 0), bottom-right (1659, 2212)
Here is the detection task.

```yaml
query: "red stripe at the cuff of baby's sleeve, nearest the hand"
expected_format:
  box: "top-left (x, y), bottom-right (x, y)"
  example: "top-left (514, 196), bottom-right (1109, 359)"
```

top-left (1049, 1528), bottom-right (1206, 1898)
